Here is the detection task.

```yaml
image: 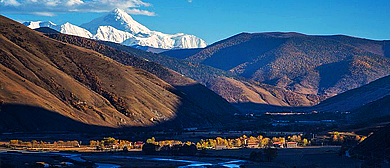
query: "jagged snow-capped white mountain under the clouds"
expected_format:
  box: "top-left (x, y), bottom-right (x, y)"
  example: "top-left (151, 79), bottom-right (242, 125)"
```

top-left (23, 9), bottom-right (207, 49)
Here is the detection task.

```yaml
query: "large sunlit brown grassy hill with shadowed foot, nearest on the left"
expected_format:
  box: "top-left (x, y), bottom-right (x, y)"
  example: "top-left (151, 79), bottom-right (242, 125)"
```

top-left (0, 16), bottom-right (229, 131)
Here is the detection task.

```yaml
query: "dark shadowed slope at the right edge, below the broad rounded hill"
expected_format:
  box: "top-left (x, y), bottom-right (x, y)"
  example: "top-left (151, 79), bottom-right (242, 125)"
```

top-left (315, 76), bottom-right (390, 111)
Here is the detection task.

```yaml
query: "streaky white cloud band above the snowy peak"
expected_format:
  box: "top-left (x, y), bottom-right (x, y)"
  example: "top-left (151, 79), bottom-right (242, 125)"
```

top-left (0, 0), bottom-right (156, 16)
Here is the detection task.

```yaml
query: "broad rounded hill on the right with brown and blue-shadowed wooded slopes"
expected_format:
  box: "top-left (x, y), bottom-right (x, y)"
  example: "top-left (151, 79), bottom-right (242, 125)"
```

top-left (183, 32), bottom-right (390, 97)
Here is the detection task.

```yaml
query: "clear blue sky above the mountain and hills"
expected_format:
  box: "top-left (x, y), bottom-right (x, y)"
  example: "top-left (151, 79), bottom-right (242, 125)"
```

top-left (0, 0), bottom-right (390, 44)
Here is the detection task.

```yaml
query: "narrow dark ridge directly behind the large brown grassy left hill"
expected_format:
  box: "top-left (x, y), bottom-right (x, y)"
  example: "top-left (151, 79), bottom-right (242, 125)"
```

top-left (41, 34), bottom-right (238, 123)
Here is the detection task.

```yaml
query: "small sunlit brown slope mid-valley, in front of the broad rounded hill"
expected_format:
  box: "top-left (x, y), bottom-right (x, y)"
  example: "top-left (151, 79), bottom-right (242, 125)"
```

top-left (207, 76), bottom-right (321, 106)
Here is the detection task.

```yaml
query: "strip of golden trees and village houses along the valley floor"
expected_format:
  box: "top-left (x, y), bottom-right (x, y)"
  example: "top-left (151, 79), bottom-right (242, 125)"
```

top-left (3, 132), bottom-right (366, 152)
